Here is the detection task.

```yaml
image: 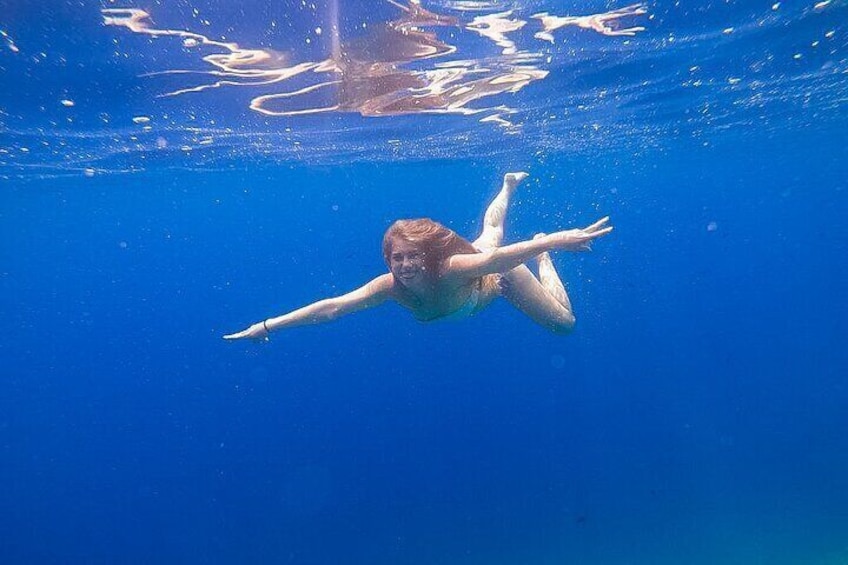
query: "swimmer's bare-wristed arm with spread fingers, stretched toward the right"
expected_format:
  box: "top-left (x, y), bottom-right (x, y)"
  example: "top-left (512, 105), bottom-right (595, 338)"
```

top-left (444, 216), bottom-right (612, 279)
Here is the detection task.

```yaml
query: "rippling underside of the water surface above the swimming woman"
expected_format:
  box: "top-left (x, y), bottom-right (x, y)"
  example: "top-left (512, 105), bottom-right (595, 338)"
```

top-left (0, 0), bottom-right (848, 177)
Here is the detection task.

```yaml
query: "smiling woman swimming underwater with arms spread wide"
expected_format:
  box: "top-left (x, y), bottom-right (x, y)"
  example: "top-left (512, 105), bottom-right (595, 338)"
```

top-left (224, 172), bottom-right (612, 339)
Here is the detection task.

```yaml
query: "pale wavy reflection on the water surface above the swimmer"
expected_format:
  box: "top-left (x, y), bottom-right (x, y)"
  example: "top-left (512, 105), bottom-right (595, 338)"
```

top-left (103, 0), bottom-right (647, 127)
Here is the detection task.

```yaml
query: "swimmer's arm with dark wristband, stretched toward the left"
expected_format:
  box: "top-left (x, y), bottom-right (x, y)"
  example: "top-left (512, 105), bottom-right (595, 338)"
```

top-left (224, 274), bottom-right (394, 339)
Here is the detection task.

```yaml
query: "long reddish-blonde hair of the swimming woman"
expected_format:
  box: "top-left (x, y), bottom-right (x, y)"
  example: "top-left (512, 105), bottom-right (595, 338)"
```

top-left (383, 218), bottom-right (479, 276)
